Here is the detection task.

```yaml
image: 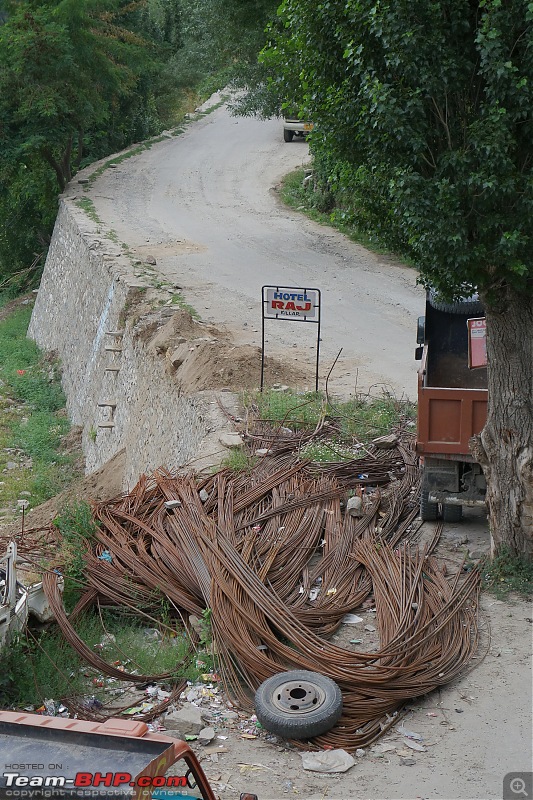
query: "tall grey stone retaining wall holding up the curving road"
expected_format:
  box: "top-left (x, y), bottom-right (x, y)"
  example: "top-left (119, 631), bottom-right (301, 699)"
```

top-left (28, 198), bottom-right (229, 490)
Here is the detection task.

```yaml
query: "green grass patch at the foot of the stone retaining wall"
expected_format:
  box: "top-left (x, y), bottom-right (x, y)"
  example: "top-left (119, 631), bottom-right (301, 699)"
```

top-left (0, 304), bottom-right (80, 519)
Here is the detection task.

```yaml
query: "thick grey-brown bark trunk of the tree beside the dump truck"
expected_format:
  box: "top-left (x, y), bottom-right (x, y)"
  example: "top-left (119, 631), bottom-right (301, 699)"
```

top-left (474, 289), bottom-right (533, 558)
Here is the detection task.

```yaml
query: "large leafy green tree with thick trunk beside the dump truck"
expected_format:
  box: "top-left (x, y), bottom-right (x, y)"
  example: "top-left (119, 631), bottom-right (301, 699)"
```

top-left (254, 0), bottom-right (533, 556)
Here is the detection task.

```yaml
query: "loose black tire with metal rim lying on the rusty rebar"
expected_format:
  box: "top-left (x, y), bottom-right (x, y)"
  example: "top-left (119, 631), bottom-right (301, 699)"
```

top-left (255, 669), bottom-right (342, 739)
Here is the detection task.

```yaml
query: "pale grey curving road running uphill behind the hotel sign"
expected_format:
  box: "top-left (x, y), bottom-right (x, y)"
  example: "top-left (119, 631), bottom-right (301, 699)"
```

top-left (92, 101), bottom-right (424, 397)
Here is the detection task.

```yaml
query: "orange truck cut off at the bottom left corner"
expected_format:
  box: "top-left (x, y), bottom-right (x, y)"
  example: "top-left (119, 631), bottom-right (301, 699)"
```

top-left (0, 711), bottom-right (257, 800)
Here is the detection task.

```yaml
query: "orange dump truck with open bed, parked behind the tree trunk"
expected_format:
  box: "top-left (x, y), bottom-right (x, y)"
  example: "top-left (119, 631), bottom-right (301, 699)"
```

top-left (415, 291), bottom-right (487, 522)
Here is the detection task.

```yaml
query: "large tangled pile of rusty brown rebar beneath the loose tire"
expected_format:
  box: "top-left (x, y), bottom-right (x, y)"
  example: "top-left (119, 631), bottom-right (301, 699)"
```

top-left (43, 438), bottom-right (479, 750)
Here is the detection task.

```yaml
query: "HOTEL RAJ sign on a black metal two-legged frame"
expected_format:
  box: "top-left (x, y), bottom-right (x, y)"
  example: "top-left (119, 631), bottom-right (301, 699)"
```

top-left (261, 286), bottom-right (320, 392)
